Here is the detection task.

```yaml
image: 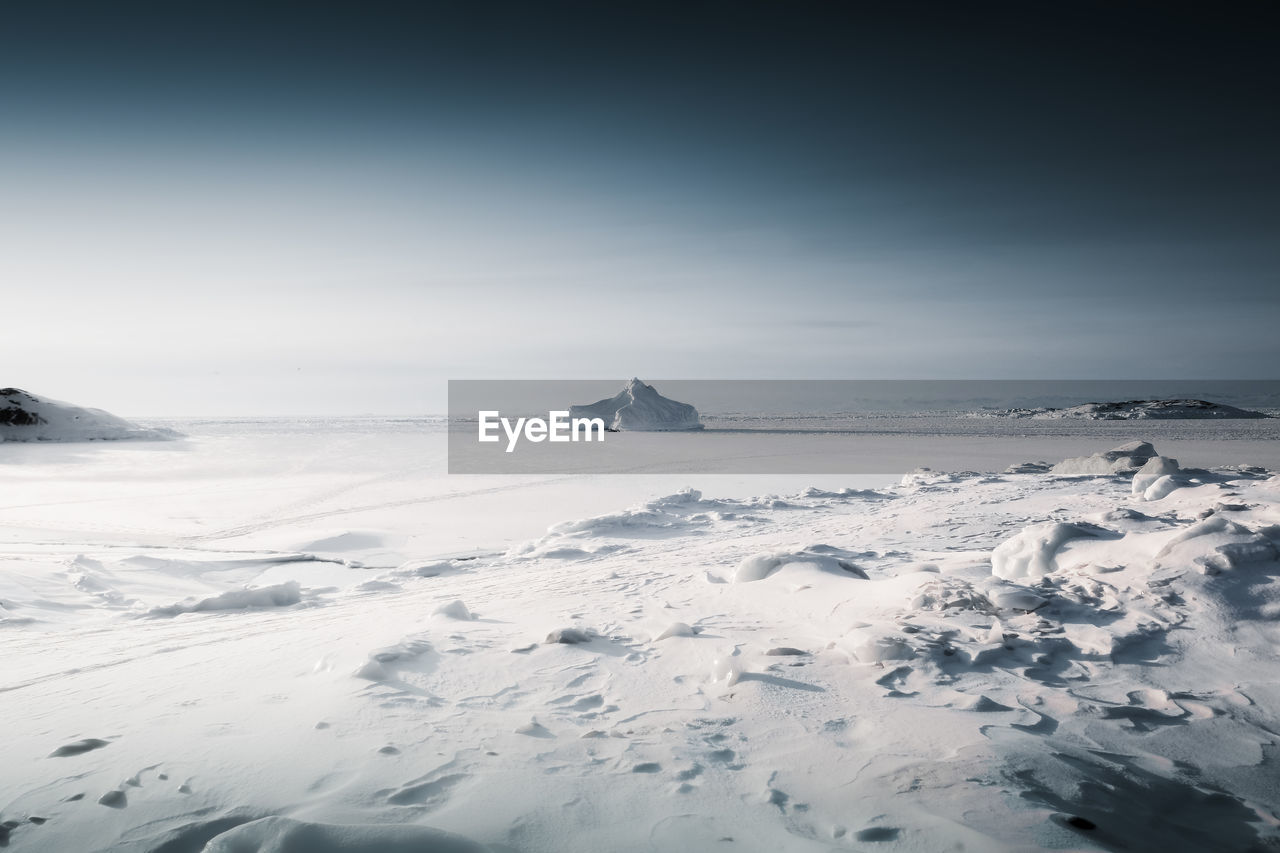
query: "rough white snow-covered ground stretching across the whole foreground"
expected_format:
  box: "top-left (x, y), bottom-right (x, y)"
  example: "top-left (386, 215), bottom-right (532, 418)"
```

top-left (0, 419), bottom-right (1280, 853)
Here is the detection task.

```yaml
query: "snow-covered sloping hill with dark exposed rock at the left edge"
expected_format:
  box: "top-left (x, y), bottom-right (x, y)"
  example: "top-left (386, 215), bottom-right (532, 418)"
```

top-left (0, 388), bottom-right (180, 442)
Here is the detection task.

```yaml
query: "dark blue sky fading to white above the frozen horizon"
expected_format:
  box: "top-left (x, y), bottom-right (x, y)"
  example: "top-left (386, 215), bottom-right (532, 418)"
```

top-left (0, 0), bottom-right (1280, 415)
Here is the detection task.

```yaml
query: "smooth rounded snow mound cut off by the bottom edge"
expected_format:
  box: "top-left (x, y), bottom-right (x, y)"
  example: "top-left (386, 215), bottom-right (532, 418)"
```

top-left (205, 817), bottom-right (488, 853)
